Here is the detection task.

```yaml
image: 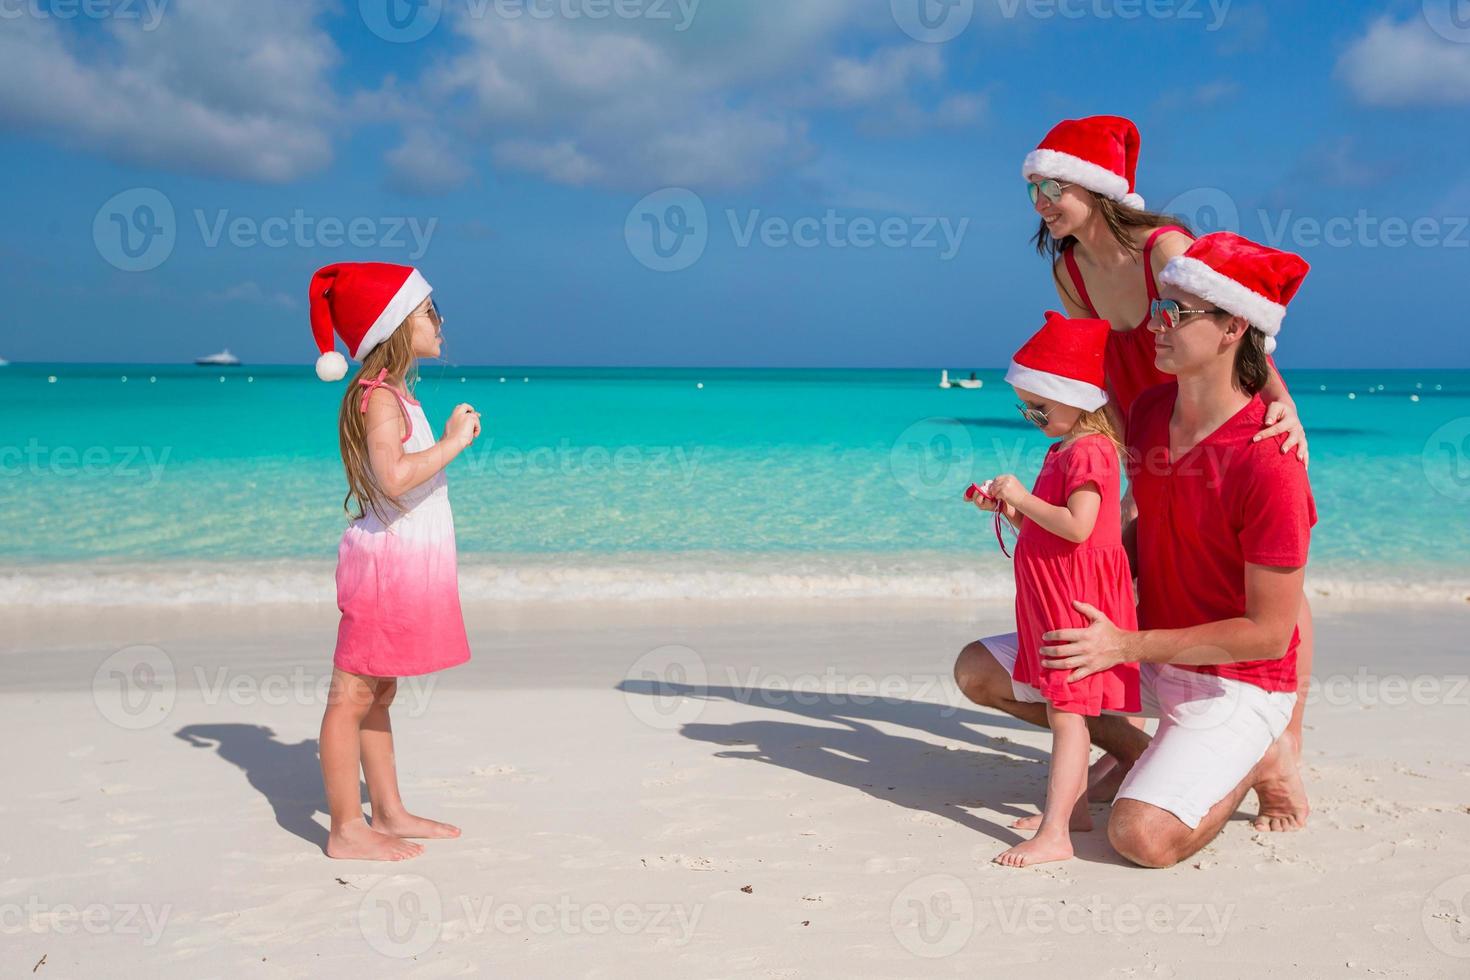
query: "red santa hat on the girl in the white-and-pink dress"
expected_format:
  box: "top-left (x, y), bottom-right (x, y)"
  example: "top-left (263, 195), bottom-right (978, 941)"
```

top-left (309, 262), bottom-right (432, 381)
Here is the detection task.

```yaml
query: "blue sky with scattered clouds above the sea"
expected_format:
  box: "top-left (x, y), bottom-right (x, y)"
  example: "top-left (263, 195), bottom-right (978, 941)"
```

top-left (0, 0), bottom-right (1470, 367)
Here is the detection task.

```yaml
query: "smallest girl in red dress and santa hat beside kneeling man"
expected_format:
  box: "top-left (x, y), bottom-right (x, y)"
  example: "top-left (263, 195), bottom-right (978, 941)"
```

top-left (976, 313), bottom-right (1139, 867)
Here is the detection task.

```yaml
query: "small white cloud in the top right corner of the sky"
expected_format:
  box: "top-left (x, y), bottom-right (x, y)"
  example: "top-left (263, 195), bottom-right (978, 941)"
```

top-left (1336, 16), bottom-right (1470, 106)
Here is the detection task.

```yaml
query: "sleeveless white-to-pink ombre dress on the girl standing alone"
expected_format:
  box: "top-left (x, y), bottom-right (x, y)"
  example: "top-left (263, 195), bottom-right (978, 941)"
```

top-left (332, 375), bottom-right (469, 677)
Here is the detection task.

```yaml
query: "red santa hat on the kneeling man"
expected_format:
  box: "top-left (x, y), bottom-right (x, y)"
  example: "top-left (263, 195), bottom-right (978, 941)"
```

top-left (1158, 231), bottom-right (1311, 354)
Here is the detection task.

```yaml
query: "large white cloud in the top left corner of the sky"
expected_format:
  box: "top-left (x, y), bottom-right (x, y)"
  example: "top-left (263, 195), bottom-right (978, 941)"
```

top-left (0, 0), bottom-right (338, 182)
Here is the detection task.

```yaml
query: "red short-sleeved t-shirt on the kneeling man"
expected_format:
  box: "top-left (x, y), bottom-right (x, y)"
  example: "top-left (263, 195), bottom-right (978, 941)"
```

top-left (1127, 383), bottom-right (1317, 691)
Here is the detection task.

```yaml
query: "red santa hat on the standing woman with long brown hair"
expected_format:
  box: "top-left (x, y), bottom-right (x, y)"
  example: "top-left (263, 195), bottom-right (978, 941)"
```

top-left (1020, 116), bottom-right (1144, 210)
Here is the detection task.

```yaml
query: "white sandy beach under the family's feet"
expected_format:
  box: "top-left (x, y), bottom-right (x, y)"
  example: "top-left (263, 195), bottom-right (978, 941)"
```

top-left (0, 601), bottom-right (1470, 979)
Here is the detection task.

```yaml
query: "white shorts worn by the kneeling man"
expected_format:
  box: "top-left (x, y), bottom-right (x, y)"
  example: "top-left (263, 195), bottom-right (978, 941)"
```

top-left (980, 633), bottom-right (1297, 830)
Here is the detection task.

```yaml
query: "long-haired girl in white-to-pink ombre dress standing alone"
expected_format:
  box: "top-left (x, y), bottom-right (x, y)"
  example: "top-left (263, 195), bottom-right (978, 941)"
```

top-left (310, 263), bottom-right (479, 861)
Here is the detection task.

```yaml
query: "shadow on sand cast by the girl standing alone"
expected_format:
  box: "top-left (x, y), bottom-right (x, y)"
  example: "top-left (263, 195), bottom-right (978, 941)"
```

top-left (173, 724), bottom-right (368, 852)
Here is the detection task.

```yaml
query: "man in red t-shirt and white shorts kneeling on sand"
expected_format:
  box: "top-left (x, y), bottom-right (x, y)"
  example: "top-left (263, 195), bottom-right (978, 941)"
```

top-left (954, 232), bottom-right (1317, 867)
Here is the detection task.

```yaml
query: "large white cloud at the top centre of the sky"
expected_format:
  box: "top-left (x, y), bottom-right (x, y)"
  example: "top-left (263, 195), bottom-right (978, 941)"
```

top-left (390, 0), bottom-right (985, 190)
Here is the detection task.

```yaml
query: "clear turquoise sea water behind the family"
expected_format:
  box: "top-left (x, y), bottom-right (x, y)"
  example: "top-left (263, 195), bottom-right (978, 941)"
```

top-left (0, 364), bottom-right (1470, 602)
